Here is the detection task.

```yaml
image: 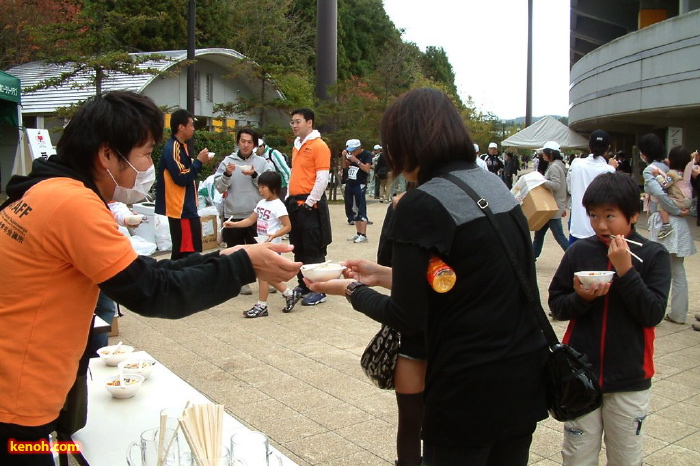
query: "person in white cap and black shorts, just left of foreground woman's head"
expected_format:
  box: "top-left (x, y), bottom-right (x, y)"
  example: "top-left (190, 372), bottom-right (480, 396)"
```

top-left (343, 139), bottom-right (372, 243)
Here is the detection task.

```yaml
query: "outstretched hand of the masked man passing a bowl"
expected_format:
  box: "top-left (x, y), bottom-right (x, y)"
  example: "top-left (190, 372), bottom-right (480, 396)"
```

top-left (221, 243), bottom-right (302, 283)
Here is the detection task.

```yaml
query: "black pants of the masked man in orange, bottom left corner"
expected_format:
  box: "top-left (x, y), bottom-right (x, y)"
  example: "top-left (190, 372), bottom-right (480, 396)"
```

top-left (0, 422), bottom-right (55, 466)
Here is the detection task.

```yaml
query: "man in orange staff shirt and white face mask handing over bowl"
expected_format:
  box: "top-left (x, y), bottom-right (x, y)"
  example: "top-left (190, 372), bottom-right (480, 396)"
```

top-left (0, 91), bottom-right (301, 466)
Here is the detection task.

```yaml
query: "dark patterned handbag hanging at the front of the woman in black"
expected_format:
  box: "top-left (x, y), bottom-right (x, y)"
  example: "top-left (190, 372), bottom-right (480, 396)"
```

top-left (360, 325), bottom-right (401, 390)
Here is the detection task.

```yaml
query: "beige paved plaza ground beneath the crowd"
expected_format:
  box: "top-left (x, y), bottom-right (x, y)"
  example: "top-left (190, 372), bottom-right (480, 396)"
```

top-left (116, 201), bottom-right (700, 466)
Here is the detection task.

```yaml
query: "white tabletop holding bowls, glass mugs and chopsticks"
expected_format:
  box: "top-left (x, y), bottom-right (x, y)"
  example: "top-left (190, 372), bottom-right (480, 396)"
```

top-left (72, 351), bottom-right (296, 466)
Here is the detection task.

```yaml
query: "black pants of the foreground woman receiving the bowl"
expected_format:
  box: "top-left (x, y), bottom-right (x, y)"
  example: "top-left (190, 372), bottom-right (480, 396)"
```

top-left (423, 424), bottom-right (537, 466)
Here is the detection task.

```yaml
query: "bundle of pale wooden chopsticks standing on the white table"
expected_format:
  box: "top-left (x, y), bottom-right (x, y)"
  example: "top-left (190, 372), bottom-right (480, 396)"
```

top-left (179, 404), bottom-right (224, 466)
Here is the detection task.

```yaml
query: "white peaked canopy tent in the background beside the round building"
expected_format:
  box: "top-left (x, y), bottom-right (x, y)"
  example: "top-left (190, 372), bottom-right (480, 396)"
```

top-left (501, 116), bottom-right (588, 149)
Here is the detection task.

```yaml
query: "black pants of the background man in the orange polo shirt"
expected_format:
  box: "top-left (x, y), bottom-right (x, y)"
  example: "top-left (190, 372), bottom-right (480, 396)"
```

top-left (289, 207), bottom-right (326, 293)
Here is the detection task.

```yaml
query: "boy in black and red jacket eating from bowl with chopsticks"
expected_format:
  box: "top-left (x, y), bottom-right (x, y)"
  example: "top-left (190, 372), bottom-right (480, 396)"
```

top-left (549, 173), bottom-right (671, 465)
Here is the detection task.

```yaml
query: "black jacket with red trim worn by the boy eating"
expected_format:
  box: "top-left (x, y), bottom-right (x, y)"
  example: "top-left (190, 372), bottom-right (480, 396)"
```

top-left (549, 231), bottom-right (671, 393)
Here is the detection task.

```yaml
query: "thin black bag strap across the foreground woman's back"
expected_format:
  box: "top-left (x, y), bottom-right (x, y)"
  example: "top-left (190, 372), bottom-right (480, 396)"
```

top-left (440, 173), bottom-right (560, 348)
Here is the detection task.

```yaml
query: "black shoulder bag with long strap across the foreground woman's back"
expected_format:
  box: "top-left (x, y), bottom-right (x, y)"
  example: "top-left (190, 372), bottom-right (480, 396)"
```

top-left (441, 173), bottom-right (603, 422)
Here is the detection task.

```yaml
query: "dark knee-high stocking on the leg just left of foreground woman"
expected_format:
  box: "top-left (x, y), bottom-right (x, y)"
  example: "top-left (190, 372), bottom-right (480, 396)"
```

top-left (396, 392), bottom-right (423, 466)
